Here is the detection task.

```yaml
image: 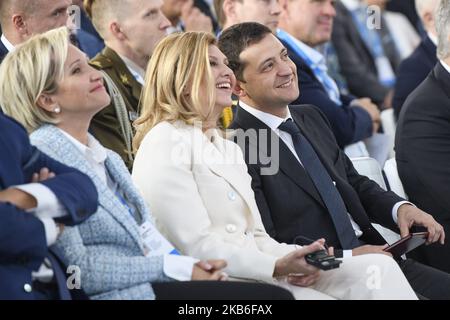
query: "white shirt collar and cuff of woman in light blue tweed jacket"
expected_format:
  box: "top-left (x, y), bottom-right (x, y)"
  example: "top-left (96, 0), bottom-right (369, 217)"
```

top-left (59, 129), bottom-right (199, 281)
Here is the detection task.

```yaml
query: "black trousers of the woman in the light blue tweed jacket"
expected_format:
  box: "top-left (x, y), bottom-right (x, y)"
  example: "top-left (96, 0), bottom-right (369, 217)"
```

top-left (152, 281), bottom-right (294, 300)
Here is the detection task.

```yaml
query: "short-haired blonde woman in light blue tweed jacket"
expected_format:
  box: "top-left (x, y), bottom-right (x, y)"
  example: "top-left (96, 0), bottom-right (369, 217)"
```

top-left (0, 28), bottom-right (292, 300)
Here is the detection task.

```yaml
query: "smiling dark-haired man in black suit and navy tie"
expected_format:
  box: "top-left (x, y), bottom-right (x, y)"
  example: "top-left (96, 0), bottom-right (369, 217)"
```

top-left (219, 23), bottom-right (450, 299)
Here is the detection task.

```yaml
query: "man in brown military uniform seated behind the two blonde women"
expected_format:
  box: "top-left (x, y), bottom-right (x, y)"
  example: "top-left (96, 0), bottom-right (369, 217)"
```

top-left (84, 0), bottom-right (170, 170)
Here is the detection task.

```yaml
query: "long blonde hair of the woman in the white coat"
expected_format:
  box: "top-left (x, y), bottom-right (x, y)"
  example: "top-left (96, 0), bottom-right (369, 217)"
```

top-left (133, 32), bottom-right (216, 151)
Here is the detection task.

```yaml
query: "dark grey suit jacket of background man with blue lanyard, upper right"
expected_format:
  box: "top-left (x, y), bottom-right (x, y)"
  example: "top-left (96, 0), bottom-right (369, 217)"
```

top-left (332, 1), bottom-right (389, 105)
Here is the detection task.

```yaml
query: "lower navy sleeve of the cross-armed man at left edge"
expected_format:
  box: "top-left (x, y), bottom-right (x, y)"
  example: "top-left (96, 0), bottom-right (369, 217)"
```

top-left (0, 203), bottom-right (47, 270)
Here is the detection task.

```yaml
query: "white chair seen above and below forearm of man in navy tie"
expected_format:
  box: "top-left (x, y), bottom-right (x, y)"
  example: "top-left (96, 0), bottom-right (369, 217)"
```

top-left (350, 157), bottom-right (400, 243)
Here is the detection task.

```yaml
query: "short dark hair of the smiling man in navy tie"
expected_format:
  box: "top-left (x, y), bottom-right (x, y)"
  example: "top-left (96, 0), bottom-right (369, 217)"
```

top-left (218, 22), bottom-right (272, 82)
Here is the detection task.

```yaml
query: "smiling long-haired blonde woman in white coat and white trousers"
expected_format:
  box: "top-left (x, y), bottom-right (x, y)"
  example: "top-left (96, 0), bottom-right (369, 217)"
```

top-left (132, 33), bottom-right (416, 299)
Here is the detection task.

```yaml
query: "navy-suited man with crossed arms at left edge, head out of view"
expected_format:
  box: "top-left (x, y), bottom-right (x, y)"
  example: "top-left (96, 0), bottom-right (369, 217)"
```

top-left (0, 112), bottom-right (97, 300)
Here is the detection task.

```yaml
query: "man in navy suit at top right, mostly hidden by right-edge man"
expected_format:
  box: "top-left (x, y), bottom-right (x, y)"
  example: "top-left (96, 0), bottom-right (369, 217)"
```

top-left (392, 0), bottom-right (439, 119)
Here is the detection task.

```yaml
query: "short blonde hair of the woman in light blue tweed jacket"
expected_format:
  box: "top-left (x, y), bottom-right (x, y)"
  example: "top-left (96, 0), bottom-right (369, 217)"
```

top-left (0, 27), bottom-right (69, 133)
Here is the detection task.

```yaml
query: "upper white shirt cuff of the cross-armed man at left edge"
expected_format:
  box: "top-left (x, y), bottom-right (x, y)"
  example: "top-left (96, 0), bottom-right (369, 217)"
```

top-left (14, 183), bottom-right (67, 218)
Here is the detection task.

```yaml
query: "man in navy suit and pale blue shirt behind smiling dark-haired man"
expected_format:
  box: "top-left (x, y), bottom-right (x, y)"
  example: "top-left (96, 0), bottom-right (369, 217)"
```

top-left (277, 0), bottom-right (380, 147)
